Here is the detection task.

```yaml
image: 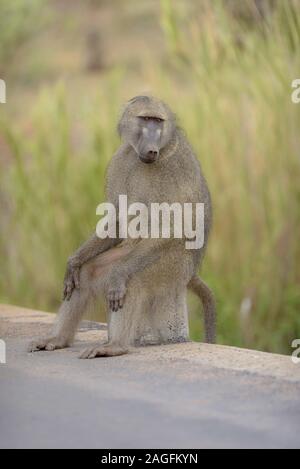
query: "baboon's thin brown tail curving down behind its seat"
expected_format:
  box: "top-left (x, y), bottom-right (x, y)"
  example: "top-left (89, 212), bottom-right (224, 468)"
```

top-left (188, 275), bottom-right (216, 344)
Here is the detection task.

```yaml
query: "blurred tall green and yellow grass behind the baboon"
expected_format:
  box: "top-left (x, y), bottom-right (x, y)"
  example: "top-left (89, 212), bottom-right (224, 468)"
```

top-left (0, 0), bottom-right (300, 353)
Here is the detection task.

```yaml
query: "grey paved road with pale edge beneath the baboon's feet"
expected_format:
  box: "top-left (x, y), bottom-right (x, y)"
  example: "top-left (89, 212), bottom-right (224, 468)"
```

top-left (0, 306), bottom-right (300, 448)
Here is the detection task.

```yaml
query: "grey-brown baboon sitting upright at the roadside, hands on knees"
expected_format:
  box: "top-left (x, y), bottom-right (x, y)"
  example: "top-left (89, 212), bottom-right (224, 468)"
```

top-left (29, 96), bottom-right (215, 358)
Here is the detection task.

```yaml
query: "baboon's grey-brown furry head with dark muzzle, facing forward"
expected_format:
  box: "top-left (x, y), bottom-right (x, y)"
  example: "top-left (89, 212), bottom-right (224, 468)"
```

top-left (119, 96), bottom-right (175, 164)
